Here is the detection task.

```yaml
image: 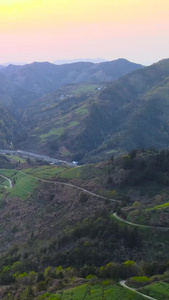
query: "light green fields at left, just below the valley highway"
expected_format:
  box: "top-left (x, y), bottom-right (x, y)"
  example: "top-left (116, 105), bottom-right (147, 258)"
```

top-left (0, 165), bottom-right (107, 199)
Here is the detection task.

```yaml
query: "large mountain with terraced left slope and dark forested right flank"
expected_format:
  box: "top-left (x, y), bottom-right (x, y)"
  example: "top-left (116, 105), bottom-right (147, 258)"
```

top-left (12, 59), bottom-right (169, 163)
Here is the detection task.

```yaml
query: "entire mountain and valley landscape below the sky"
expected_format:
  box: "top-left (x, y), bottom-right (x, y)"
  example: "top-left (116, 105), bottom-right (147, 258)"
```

top-left (0, 59), bottom-right (169, 300)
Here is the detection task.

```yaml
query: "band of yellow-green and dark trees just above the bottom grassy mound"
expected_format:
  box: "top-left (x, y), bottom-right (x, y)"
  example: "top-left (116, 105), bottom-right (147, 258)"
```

top-left (0, 260), bottom-right (169, 300)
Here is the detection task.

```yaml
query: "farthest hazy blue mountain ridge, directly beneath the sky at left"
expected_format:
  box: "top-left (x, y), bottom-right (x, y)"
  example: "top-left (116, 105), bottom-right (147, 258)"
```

top-left (0, 59), bottom-right (143, 110)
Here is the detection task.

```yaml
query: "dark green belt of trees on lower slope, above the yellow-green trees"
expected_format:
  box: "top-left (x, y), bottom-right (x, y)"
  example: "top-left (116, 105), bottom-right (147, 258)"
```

top-left (0, 210), bottom-right (142, 278)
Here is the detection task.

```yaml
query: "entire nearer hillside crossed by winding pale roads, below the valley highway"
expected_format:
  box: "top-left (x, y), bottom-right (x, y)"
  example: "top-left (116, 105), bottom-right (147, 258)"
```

top-left (0, 149), bottom-right (169, 300)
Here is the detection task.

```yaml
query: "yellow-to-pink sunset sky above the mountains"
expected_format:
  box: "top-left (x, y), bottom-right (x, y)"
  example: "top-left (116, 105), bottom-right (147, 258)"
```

top-left (0, 0), bottom-right (169, 65)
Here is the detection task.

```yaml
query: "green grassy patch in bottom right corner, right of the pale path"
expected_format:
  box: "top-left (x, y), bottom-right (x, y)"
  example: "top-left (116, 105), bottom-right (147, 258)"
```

top-left (139, 281), bottom-right (169, 300)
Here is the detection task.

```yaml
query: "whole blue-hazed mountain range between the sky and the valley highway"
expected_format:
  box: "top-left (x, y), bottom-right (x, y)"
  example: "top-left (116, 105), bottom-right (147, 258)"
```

top-left (0, 59), bottom-right (169, 163)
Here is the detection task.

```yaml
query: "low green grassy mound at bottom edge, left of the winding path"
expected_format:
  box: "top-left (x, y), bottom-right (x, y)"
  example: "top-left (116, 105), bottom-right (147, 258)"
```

top-left (37, 283), bottom-right (145, 300)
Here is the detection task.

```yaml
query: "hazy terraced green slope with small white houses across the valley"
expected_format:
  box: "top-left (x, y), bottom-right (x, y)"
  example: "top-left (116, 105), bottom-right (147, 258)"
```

top-left (14, 83), bottom-right (106, 160)
